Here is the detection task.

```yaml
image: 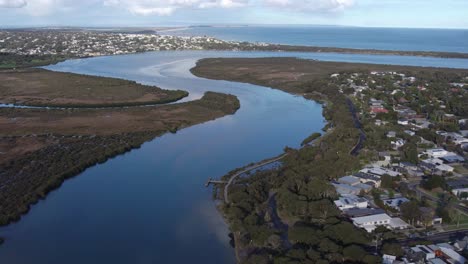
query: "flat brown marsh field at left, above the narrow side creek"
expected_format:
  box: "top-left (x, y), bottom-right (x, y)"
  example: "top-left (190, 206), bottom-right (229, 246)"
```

top-left (0, 69), bottom-right (188, 107)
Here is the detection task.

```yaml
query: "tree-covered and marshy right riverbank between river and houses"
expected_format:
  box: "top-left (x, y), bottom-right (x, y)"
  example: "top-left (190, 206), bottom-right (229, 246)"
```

top-left (192, 58), bottom-right (467, 263)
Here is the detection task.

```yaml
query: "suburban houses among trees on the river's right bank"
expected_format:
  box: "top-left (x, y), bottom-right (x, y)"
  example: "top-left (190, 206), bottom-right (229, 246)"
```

top-left (330, 71), bottom-right (468, 264)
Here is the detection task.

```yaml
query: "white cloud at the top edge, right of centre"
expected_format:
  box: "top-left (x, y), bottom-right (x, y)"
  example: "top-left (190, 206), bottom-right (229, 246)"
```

top-left (263, 0), bottom-right (355, 12)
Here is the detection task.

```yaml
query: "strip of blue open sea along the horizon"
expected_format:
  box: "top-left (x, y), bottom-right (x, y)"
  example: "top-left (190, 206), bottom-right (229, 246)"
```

top-left (166, 26), bottom-right (468, 53)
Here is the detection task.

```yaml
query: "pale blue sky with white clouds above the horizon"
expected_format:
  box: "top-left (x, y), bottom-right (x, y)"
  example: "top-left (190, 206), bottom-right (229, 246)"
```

top-left (0, 0), bottom-right (468, 29)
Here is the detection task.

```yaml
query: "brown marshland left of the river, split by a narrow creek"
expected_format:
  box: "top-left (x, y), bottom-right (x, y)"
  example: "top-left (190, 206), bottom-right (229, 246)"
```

top-left (0, 66), bottom-right (240, 225)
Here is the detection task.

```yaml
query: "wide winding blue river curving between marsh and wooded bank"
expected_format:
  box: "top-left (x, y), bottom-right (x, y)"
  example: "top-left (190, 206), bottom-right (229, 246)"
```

top-left (0, 51), bottom-right (468, 264)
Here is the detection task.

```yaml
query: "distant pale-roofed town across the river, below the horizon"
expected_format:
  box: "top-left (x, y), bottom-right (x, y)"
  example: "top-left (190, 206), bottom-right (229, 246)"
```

top-left (0, 30), bottom-right (266, 58)
